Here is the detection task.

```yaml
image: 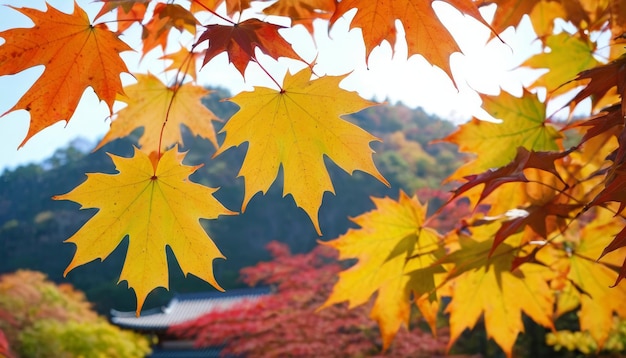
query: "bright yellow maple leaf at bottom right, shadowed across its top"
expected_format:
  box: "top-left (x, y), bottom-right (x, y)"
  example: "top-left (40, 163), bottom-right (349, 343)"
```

top-left (442, 225), bottom-right (554, 357)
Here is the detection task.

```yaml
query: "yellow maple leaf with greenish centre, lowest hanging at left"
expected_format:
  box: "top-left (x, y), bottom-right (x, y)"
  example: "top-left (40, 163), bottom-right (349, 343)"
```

top-left (53, 146), bottom-right (235, 315)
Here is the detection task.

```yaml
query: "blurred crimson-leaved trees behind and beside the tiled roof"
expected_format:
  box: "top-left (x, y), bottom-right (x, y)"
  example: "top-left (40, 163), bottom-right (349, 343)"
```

top-left (168, 242), bottom-right (448, 357)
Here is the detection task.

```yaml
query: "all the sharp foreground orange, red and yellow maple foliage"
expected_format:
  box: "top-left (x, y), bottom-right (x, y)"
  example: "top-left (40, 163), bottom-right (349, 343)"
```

top-left (0, 0), bottom-right (626, 356)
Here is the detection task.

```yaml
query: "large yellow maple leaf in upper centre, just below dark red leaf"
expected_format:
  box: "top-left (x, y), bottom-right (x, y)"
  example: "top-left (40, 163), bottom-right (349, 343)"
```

top-left (216, 67), bottom-right (389, 234)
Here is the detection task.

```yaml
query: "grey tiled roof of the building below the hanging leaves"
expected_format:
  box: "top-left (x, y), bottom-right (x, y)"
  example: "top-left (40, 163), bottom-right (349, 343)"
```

top-left (111, 288), bottom-right (270, 330)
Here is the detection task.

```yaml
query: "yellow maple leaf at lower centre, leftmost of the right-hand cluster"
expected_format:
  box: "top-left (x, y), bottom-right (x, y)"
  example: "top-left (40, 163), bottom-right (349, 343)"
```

top-left (322, 191), bottom-right (443, 349)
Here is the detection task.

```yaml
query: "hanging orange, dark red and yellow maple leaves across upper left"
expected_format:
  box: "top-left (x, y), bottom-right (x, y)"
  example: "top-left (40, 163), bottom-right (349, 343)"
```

top-left (0, 0), bottom-right (466, 313)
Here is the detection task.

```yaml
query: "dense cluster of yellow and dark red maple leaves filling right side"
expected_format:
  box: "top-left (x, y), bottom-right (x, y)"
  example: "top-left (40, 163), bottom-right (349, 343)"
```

top-left (316, 1), bottom-right (626, 355)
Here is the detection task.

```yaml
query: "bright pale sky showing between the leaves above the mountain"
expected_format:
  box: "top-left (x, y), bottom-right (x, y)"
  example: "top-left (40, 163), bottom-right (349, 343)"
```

top-left (0, 0), bottom-right (539, 172)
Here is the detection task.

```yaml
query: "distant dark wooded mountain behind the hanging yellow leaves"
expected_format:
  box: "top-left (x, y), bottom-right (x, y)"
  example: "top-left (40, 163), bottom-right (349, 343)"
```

top-left (0, 90), bottom-right (462, 313)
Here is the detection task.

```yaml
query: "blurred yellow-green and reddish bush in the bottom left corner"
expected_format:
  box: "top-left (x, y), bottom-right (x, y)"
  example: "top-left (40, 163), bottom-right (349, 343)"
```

top-left (0, 271), bottom-right (150, 357)
